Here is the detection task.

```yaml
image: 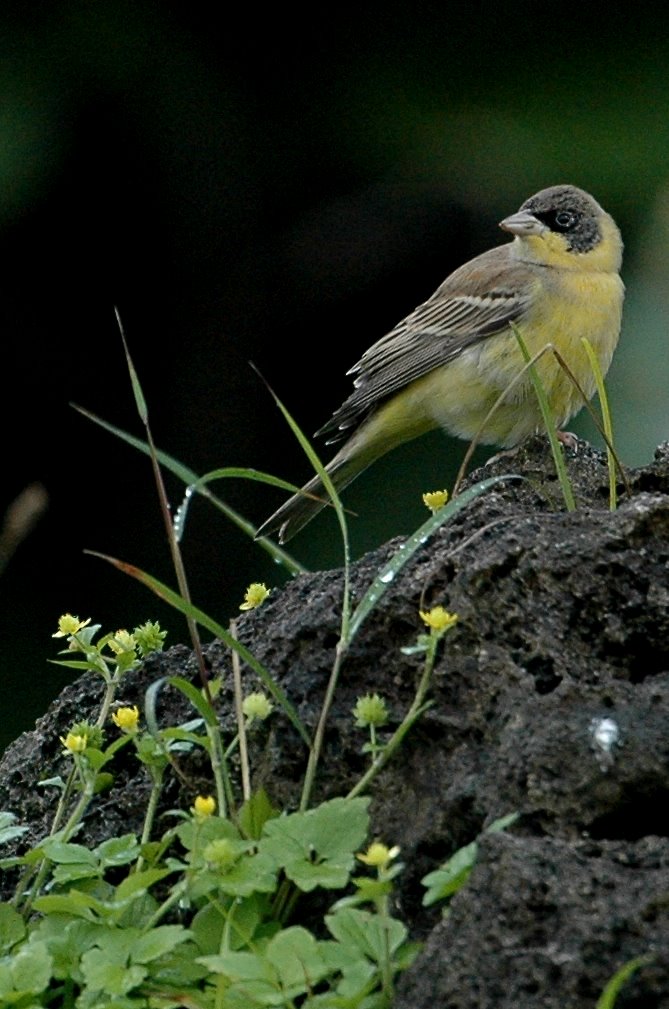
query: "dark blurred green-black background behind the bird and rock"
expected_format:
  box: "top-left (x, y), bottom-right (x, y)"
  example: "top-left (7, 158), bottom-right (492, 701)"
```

top-left (0, 0), bottom-right (669, 747)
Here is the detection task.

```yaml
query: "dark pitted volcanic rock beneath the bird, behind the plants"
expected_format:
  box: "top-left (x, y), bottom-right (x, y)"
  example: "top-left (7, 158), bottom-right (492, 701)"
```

top-left (0, 439), bottom-right (669, 1009)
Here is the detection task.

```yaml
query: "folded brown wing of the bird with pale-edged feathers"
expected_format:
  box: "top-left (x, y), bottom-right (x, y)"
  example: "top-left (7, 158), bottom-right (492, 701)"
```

top-left (317, 243), bottom-right (531, 444)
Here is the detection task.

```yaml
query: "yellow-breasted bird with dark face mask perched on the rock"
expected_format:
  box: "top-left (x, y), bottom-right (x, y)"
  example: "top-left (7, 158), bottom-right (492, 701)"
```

top-left (255, 185), bottom-right (625, 543)
